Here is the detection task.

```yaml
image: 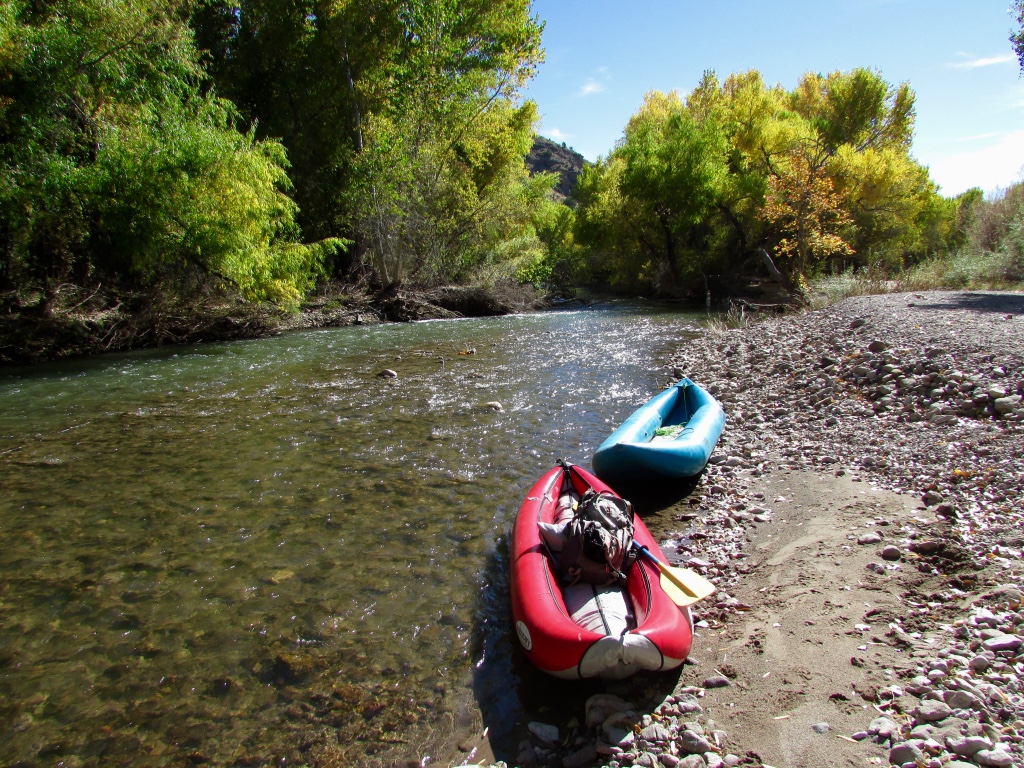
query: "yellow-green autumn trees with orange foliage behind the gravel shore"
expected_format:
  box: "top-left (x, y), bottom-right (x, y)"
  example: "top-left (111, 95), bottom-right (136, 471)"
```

top-left (561, 69), bottom-right (1024, 303)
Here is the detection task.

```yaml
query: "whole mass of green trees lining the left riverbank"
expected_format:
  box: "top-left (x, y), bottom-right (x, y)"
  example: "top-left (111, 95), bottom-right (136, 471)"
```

top-left (0, 0), bottom-right (558, 359)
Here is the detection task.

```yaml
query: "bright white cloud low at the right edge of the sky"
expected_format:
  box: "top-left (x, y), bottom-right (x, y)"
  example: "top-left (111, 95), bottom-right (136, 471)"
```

top-left (922, 130), bottom-right (1024, 197)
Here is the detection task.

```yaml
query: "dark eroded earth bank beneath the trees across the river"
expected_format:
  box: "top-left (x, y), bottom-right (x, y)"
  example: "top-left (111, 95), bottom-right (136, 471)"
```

top-left (0, 283), bottom-right (549, 367)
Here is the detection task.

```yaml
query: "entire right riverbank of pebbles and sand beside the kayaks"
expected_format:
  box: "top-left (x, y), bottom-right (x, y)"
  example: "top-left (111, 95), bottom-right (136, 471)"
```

top-left (485, 292), bottom-right (1024, 768)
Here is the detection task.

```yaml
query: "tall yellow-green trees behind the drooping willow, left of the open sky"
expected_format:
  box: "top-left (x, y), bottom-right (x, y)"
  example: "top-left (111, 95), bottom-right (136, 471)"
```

top-left (194, 0), bottom-right (544, 285)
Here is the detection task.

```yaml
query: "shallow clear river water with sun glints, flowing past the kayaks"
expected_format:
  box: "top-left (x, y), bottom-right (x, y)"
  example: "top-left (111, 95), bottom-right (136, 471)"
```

top-left (0, 303), bottom-right (699, 766)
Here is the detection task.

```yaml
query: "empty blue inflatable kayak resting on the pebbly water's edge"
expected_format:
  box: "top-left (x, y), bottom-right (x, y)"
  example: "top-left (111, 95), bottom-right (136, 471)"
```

top-left (593, 379), bottom-right (725, 487)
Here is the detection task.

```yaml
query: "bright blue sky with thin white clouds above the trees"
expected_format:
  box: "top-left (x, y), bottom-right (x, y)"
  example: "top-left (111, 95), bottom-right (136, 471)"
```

top-left (526, 0), bottom-right (1024, 196)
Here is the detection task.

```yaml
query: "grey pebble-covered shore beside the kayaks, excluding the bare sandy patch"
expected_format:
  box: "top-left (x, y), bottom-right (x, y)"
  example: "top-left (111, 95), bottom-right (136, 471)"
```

top-left (481, 292), bottom-right (1024, 768)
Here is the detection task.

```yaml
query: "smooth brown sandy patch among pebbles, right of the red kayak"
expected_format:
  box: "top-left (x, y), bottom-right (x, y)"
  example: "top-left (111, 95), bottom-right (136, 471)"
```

top-left (681, 471), bottom-right (938, 767)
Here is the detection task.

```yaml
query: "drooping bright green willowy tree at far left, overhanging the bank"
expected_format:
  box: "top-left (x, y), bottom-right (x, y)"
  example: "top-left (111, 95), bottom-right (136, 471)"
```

top-left (0, 0), bottom-right (340, 313)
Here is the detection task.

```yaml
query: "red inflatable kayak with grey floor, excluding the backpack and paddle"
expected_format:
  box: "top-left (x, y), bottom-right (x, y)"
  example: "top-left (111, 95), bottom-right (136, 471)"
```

top-left (511, 465), bottom-right (693, 679)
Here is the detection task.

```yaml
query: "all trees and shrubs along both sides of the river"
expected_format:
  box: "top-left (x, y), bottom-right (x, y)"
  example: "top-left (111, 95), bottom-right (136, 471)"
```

top-left (0, 0), bottom-right (1024, 362)
